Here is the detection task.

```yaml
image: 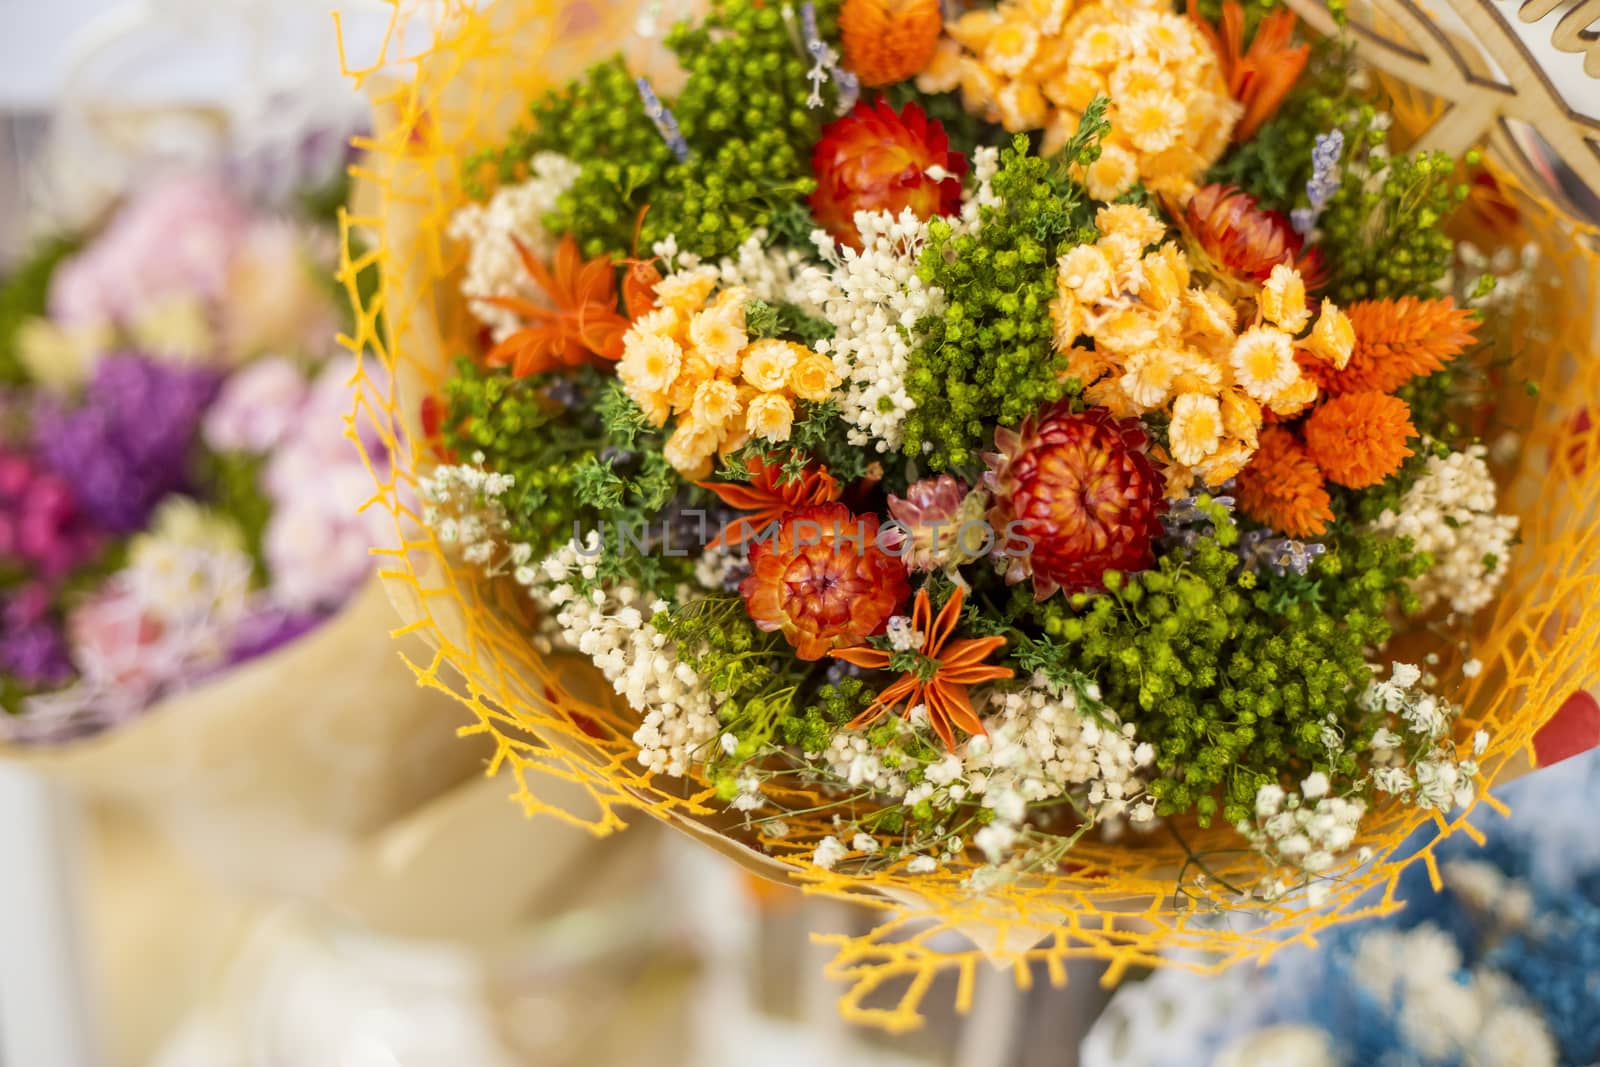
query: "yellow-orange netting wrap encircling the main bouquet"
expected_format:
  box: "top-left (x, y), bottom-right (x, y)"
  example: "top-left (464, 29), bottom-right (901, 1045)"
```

top-left (342, 0), bottom-right (1600, 1029)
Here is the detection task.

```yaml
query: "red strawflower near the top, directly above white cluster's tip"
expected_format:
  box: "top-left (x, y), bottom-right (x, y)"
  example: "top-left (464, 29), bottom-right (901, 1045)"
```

top-left (811, 98), bottom-right (966, 248)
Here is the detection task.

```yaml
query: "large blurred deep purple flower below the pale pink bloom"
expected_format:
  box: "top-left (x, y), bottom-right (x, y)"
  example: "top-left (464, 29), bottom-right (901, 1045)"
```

top-left (34, 354), bottom-right (221, 533)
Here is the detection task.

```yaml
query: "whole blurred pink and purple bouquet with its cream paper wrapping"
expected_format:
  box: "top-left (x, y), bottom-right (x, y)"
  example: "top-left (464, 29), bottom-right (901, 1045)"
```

top-left (0, 139), bottom-right (499, 908)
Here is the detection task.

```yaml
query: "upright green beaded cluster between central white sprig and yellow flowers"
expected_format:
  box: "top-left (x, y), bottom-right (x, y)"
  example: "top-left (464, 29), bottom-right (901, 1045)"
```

top-left (906, 122), bottom-right (1104, 470)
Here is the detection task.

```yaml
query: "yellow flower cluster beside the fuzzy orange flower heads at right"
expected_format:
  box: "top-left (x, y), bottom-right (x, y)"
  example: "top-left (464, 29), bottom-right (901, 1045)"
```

top-left (1050, 203), bottom-right (1355, 496)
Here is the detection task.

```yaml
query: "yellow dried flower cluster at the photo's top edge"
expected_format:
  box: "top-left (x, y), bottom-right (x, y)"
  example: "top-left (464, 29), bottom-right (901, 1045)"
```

top-left (917, 0), bottom-right (1240, 200)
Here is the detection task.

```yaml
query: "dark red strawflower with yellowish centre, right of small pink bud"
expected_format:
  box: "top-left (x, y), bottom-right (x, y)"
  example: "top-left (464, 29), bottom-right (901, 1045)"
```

top-left (984, 400), bottom-right (1166, 600)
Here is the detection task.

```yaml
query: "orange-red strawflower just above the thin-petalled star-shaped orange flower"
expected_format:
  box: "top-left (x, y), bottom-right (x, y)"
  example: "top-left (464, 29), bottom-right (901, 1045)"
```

top-left (739, 504), bottom-right (910, 659)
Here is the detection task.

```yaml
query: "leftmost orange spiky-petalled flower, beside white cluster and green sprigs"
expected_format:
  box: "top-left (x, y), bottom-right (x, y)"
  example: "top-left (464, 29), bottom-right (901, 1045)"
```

top-left (478, 234), bottom-right (627, 378)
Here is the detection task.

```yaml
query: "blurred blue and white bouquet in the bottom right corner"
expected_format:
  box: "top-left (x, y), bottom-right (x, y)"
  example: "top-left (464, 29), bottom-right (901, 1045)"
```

top-left (1083, 742), bottom-right (1600, 1067)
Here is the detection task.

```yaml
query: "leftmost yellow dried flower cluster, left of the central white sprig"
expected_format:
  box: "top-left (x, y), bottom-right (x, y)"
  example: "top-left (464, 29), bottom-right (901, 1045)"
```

top-left (616, 267), bottom-right (840, 478)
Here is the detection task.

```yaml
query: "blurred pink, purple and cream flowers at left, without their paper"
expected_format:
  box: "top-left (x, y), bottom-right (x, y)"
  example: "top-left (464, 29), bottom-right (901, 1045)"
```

top-left (0, 171), bottom-right (384, 742)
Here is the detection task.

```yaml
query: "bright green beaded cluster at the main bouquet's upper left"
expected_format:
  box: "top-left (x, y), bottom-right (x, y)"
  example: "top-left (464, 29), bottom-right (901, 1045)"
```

top-left (466, 0), bottom-right (838, 256)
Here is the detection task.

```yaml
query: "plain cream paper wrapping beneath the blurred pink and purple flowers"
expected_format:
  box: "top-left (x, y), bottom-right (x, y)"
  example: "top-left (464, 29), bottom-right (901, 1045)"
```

top-left (5, 579), bottom-right (485, 897)
